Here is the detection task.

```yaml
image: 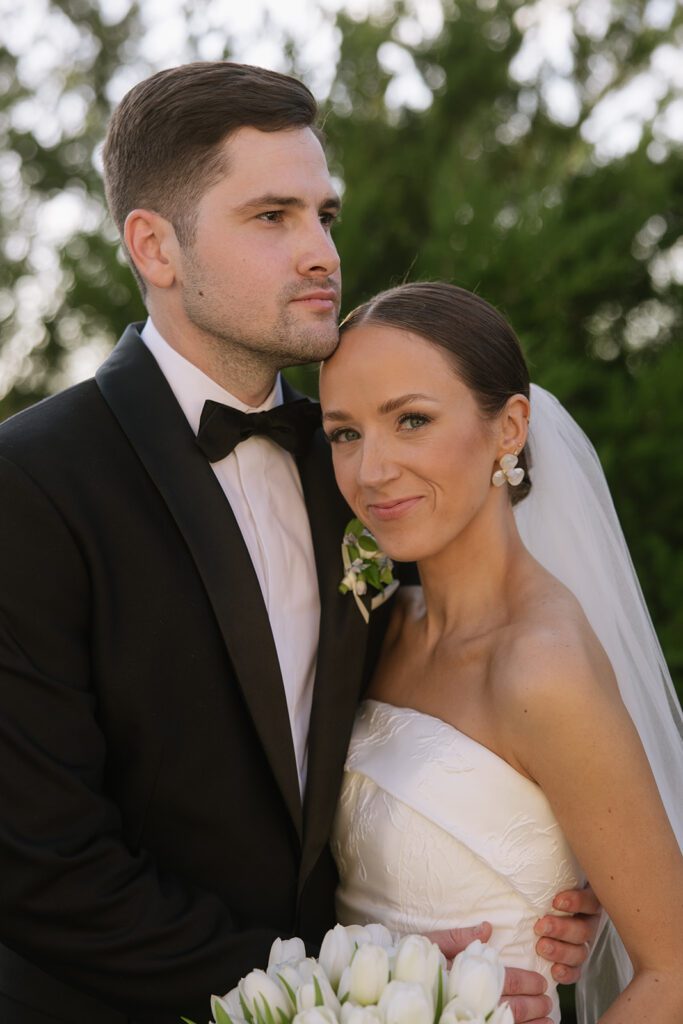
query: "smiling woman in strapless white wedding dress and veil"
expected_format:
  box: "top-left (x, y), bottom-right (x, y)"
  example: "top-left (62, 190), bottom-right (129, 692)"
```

top-left (321, 284), bottom-right (683, 1024)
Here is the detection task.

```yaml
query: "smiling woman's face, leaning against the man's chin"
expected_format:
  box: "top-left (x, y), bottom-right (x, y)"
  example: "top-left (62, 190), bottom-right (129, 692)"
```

top-left (321, 324), bottom-right (502, 561)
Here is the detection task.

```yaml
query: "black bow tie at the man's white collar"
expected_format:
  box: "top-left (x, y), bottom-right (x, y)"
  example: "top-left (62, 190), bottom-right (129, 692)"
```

top-left (197, 398), bottom-right (322, 462)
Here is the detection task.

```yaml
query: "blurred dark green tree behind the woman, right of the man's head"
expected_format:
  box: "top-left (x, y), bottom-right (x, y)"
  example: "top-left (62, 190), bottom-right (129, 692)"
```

top-left (327, 0), bottom-right (683, 694)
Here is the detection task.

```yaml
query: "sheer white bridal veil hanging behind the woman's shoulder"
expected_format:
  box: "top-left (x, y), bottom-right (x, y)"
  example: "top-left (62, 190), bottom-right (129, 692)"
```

top-left (515, 385), bottom-right (683, 1024)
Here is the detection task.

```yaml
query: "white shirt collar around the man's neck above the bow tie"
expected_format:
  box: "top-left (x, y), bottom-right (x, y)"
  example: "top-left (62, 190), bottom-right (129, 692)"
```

top-left (140, 316), bottom-right (283, 434)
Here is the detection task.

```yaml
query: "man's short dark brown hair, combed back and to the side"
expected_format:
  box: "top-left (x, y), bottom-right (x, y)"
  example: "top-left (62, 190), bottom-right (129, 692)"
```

top-left (103, 60), bottom-right (321, 285)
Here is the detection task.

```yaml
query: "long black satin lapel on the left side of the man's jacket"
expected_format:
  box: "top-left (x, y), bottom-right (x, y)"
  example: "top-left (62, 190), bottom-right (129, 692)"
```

top-left (95, 327), bottom-right (302, 840)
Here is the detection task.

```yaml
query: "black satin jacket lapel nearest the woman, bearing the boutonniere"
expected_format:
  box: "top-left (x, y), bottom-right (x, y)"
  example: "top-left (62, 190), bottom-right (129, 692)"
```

top-left (290, 405), bottom-right (368, 886)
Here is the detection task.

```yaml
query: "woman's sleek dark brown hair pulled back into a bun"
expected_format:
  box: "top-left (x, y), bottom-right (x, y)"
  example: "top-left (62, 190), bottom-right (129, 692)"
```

top-left (339, 282), bottom-right (531, 505)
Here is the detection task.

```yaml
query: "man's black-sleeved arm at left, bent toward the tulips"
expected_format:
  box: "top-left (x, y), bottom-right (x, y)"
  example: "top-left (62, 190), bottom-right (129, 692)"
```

top-left (0, 459), bottom-right (274, 1024)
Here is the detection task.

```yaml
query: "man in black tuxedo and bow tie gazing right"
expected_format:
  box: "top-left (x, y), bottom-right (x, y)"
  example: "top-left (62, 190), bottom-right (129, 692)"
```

top-left (0, 62), bottom-right (592, 1024)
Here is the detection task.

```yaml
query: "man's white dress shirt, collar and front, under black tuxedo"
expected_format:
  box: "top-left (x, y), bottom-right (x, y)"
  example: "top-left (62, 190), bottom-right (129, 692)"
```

top-left (142, 318), bottom-right (321, 797)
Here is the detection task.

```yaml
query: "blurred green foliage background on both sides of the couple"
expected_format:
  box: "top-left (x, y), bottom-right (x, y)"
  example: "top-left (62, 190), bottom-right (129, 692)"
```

top-left (0, 0), bottom-right (683, 692)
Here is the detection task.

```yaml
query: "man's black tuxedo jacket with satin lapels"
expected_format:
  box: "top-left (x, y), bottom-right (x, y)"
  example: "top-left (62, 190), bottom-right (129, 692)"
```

top-left (0, 328), bottom-right (391, 1024)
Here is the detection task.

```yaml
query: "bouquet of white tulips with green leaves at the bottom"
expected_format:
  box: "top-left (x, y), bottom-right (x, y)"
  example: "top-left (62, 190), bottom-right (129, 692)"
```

top-left (183, 925), bottom-right (513, 1024)
